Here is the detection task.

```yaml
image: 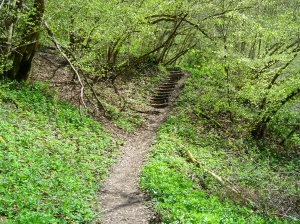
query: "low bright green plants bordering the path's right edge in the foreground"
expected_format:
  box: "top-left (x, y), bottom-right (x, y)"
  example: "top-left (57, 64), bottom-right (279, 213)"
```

top-left (141, 156), bottom-right (273, 223)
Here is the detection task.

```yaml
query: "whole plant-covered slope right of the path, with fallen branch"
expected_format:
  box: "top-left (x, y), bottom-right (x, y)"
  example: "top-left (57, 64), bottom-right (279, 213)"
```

top-left (140, 66), bottom-right (300, 223)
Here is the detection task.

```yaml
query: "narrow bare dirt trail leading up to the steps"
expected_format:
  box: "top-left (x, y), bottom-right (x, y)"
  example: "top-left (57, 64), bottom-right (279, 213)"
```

top-left (99, 69), bottom-right (189, 224)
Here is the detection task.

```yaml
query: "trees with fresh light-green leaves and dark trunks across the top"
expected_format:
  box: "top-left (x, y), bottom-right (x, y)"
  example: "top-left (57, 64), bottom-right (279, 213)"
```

top-left (0, 0), bottom-right (300, 140)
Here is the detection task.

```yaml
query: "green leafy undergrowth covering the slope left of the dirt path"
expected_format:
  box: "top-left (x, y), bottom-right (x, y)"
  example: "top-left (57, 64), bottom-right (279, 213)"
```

top-left (0, 80), bottom-right (117, 223)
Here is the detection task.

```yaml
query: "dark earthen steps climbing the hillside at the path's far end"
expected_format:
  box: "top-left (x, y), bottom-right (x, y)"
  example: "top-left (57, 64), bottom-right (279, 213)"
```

top-left (150, 68), bottom-right (184, 108)
